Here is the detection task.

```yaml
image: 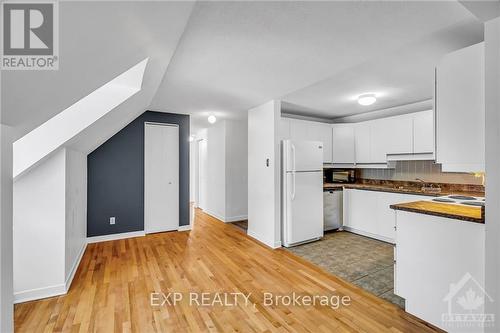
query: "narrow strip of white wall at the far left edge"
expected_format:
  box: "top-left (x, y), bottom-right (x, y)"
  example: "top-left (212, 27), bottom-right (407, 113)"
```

top-left (0, 125), bottom-right (14, 332)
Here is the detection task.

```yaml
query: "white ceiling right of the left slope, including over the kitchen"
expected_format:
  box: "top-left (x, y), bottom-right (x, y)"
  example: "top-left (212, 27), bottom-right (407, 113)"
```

top-left (151, 1), bottom-right (481, 127)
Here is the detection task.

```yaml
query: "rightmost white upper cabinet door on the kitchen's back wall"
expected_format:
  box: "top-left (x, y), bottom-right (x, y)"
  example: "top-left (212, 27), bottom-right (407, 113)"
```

top-left (413, 110), bottom-right (434, 154)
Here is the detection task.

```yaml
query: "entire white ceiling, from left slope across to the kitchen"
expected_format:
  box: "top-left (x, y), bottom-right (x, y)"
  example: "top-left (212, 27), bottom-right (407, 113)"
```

top-left (1, 1), bottom-right (482, 140)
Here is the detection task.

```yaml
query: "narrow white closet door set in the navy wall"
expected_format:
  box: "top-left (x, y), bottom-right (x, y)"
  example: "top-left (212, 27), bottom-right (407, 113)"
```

top-left (144, 123), bottom-right (179, 233)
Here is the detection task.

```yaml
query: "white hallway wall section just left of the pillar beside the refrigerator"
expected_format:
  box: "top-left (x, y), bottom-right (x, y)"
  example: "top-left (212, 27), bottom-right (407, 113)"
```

top-left (225, 119), bottom-right (248, 221)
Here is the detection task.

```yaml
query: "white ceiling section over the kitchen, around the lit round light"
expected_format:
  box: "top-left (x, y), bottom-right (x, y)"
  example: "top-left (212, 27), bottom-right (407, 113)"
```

top-left (282, 19), bottom-right (483, 119)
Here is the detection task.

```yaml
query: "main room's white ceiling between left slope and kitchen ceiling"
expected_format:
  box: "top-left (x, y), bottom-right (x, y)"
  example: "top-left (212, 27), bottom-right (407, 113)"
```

top-left (151, 1), bottom-right (475, 127)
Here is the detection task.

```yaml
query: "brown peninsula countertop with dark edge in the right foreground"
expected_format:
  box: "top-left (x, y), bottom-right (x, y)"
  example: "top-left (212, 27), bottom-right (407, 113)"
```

top-left (390, 200), bottom-right (484, 223)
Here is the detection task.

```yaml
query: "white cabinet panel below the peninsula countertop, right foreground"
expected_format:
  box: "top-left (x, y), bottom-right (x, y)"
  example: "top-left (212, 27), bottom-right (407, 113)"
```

top-left (394, 211), bottom-right (484, 332)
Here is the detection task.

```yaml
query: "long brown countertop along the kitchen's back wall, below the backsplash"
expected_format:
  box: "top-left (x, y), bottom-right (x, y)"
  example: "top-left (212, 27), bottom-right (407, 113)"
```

top-left (323, 183), bottom-right (484, 197)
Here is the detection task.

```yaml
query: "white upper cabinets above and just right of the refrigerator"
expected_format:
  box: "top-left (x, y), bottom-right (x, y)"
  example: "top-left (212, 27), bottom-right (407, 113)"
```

top-left (286, 118), bottom-right (332, 163)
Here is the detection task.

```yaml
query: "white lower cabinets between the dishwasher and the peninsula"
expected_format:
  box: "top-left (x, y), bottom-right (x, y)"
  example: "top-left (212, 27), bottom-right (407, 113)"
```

top-left (344, 189), bottom-right (429, 243)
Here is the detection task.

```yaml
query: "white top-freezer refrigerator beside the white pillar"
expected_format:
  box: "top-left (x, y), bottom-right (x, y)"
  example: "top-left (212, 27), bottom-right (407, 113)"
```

top-left (282, 140), bottom-right (323, 247)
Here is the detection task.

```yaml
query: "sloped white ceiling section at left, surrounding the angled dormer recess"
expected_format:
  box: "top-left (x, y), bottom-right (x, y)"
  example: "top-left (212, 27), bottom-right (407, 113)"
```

top-left (2, 1), bottom-right (193, 143)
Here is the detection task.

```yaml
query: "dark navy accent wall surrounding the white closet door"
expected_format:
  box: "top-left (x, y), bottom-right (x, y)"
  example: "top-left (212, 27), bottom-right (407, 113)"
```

top-left (87, 111), bottom-right (189, 237)
